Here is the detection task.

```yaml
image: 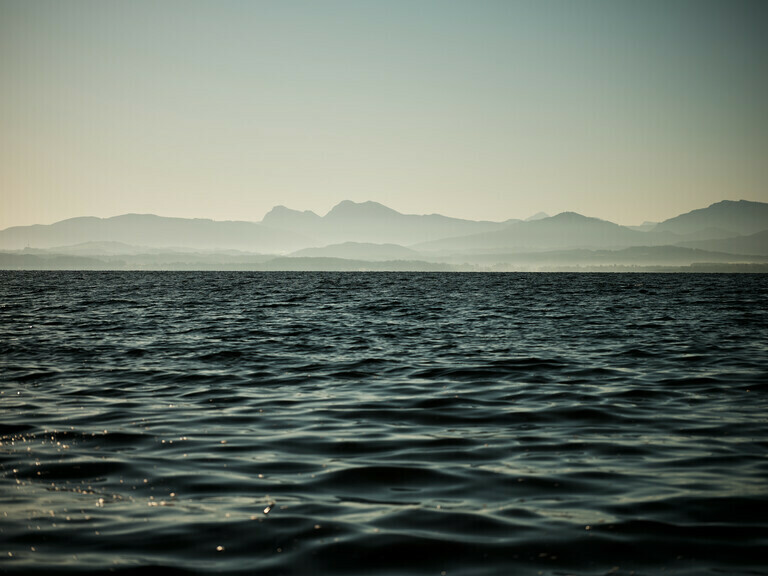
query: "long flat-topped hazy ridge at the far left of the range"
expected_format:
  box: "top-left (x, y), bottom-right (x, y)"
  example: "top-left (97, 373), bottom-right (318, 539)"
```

top-left (0, 214), bottom-right (311, 253)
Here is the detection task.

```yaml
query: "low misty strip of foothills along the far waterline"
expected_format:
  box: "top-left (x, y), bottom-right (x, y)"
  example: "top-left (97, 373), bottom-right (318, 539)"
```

top-left (0, 244), bottom-right (768, 272)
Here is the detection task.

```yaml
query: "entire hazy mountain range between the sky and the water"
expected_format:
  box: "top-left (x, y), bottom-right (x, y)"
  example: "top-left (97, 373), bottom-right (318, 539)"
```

top-left (0, 200), bottom-right (768, 270)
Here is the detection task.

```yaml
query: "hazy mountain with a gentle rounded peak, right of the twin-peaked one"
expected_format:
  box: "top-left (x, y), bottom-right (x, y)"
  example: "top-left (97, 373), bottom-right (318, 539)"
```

top-left (412, 212), bottom-right (648, 252)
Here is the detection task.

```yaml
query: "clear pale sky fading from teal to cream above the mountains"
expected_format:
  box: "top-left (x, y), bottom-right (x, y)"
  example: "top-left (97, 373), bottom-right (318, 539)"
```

top-left (0, 0), bottom-right (768, 229)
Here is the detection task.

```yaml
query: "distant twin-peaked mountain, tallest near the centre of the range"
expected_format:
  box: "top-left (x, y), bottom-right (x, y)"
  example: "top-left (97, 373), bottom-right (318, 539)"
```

top-left (262, 200), bottom-right (507, 245)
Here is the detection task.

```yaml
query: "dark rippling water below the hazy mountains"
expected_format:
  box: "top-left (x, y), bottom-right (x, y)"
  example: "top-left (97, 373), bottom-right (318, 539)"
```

top-left (0, 272), bottom-right (768, 576)
